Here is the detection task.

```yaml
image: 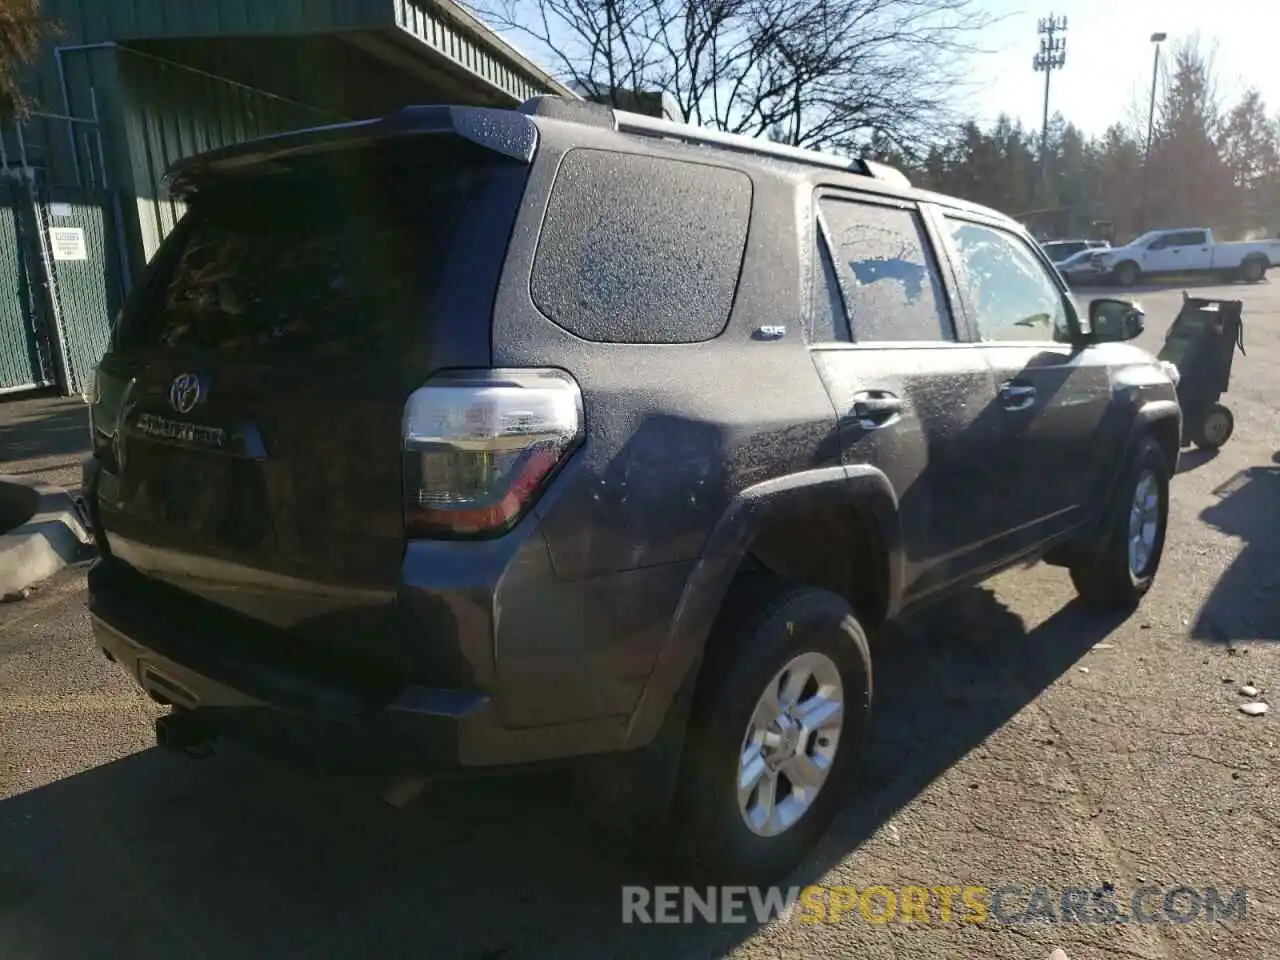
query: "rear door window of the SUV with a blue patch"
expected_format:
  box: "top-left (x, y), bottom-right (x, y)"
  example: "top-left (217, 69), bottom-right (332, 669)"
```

top-left (819, 197), bottom-right (954, 342)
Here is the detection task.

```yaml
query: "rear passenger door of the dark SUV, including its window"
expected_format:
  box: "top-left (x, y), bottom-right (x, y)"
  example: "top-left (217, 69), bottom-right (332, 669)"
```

top-left (812, 195), bottom-right (1000, 600)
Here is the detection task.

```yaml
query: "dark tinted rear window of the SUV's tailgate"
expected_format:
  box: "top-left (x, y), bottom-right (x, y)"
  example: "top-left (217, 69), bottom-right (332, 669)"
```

top-left (119, 138), bottom-right (514, 357)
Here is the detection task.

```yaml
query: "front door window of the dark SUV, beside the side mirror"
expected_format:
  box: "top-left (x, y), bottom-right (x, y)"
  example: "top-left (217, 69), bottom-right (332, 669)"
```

top-left (947, 218), bottom-right (1071, 343)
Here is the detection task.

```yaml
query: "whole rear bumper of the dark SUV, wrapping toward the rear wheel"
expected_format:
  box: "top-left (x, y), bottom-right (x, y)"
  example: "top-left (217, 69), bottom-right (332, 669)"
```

top-left (84, 448), bottom-right (694, 773)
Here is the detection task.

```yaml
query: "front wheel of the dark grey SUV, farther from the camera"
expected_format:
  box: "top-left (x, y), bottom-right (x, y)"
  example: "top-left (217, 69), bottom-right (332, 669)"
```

top-left (1070, 436), bottom-right (1169, 607)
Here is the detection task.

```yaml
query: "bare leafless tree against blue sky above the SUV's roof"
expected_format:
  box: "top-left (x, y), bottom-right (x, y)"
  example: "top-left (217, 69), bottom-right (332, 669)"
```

top-left (475, 0), bottom-right (995, 156)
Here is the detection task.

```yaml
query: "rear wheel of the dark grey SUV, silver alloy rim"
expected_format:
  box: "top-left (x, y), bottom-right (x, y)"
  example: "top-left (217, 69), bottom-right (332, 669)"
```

top-left (675, 573), bottom-right (872, 884)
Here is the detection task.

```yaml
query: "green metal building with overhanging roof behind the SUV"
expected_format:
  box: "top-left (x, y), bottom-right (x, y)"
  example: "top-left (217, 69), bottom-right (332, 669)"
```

top-left (0, 0), bottom-right (576, 394)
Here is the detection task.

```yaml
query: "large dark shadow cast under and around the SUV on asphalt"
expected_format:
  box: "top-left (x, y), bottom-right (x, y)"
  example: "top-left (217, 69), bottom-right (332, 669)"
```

top-left (0, 589), bottom-right (1119, 960)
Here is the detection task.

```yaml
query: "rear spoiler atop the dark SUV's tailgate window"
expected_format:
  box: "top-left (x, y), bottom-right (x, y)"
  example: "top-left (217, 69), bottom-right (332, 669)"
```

top-left (164, 106), bottom-right (538, 198)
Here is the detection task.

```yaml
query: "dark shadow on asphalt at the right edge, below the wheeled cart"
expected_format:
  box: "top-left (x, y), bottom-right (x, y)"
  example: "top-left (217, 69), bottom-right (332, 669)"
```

top-left (1192, 466), bottom-right (1280, 645)
